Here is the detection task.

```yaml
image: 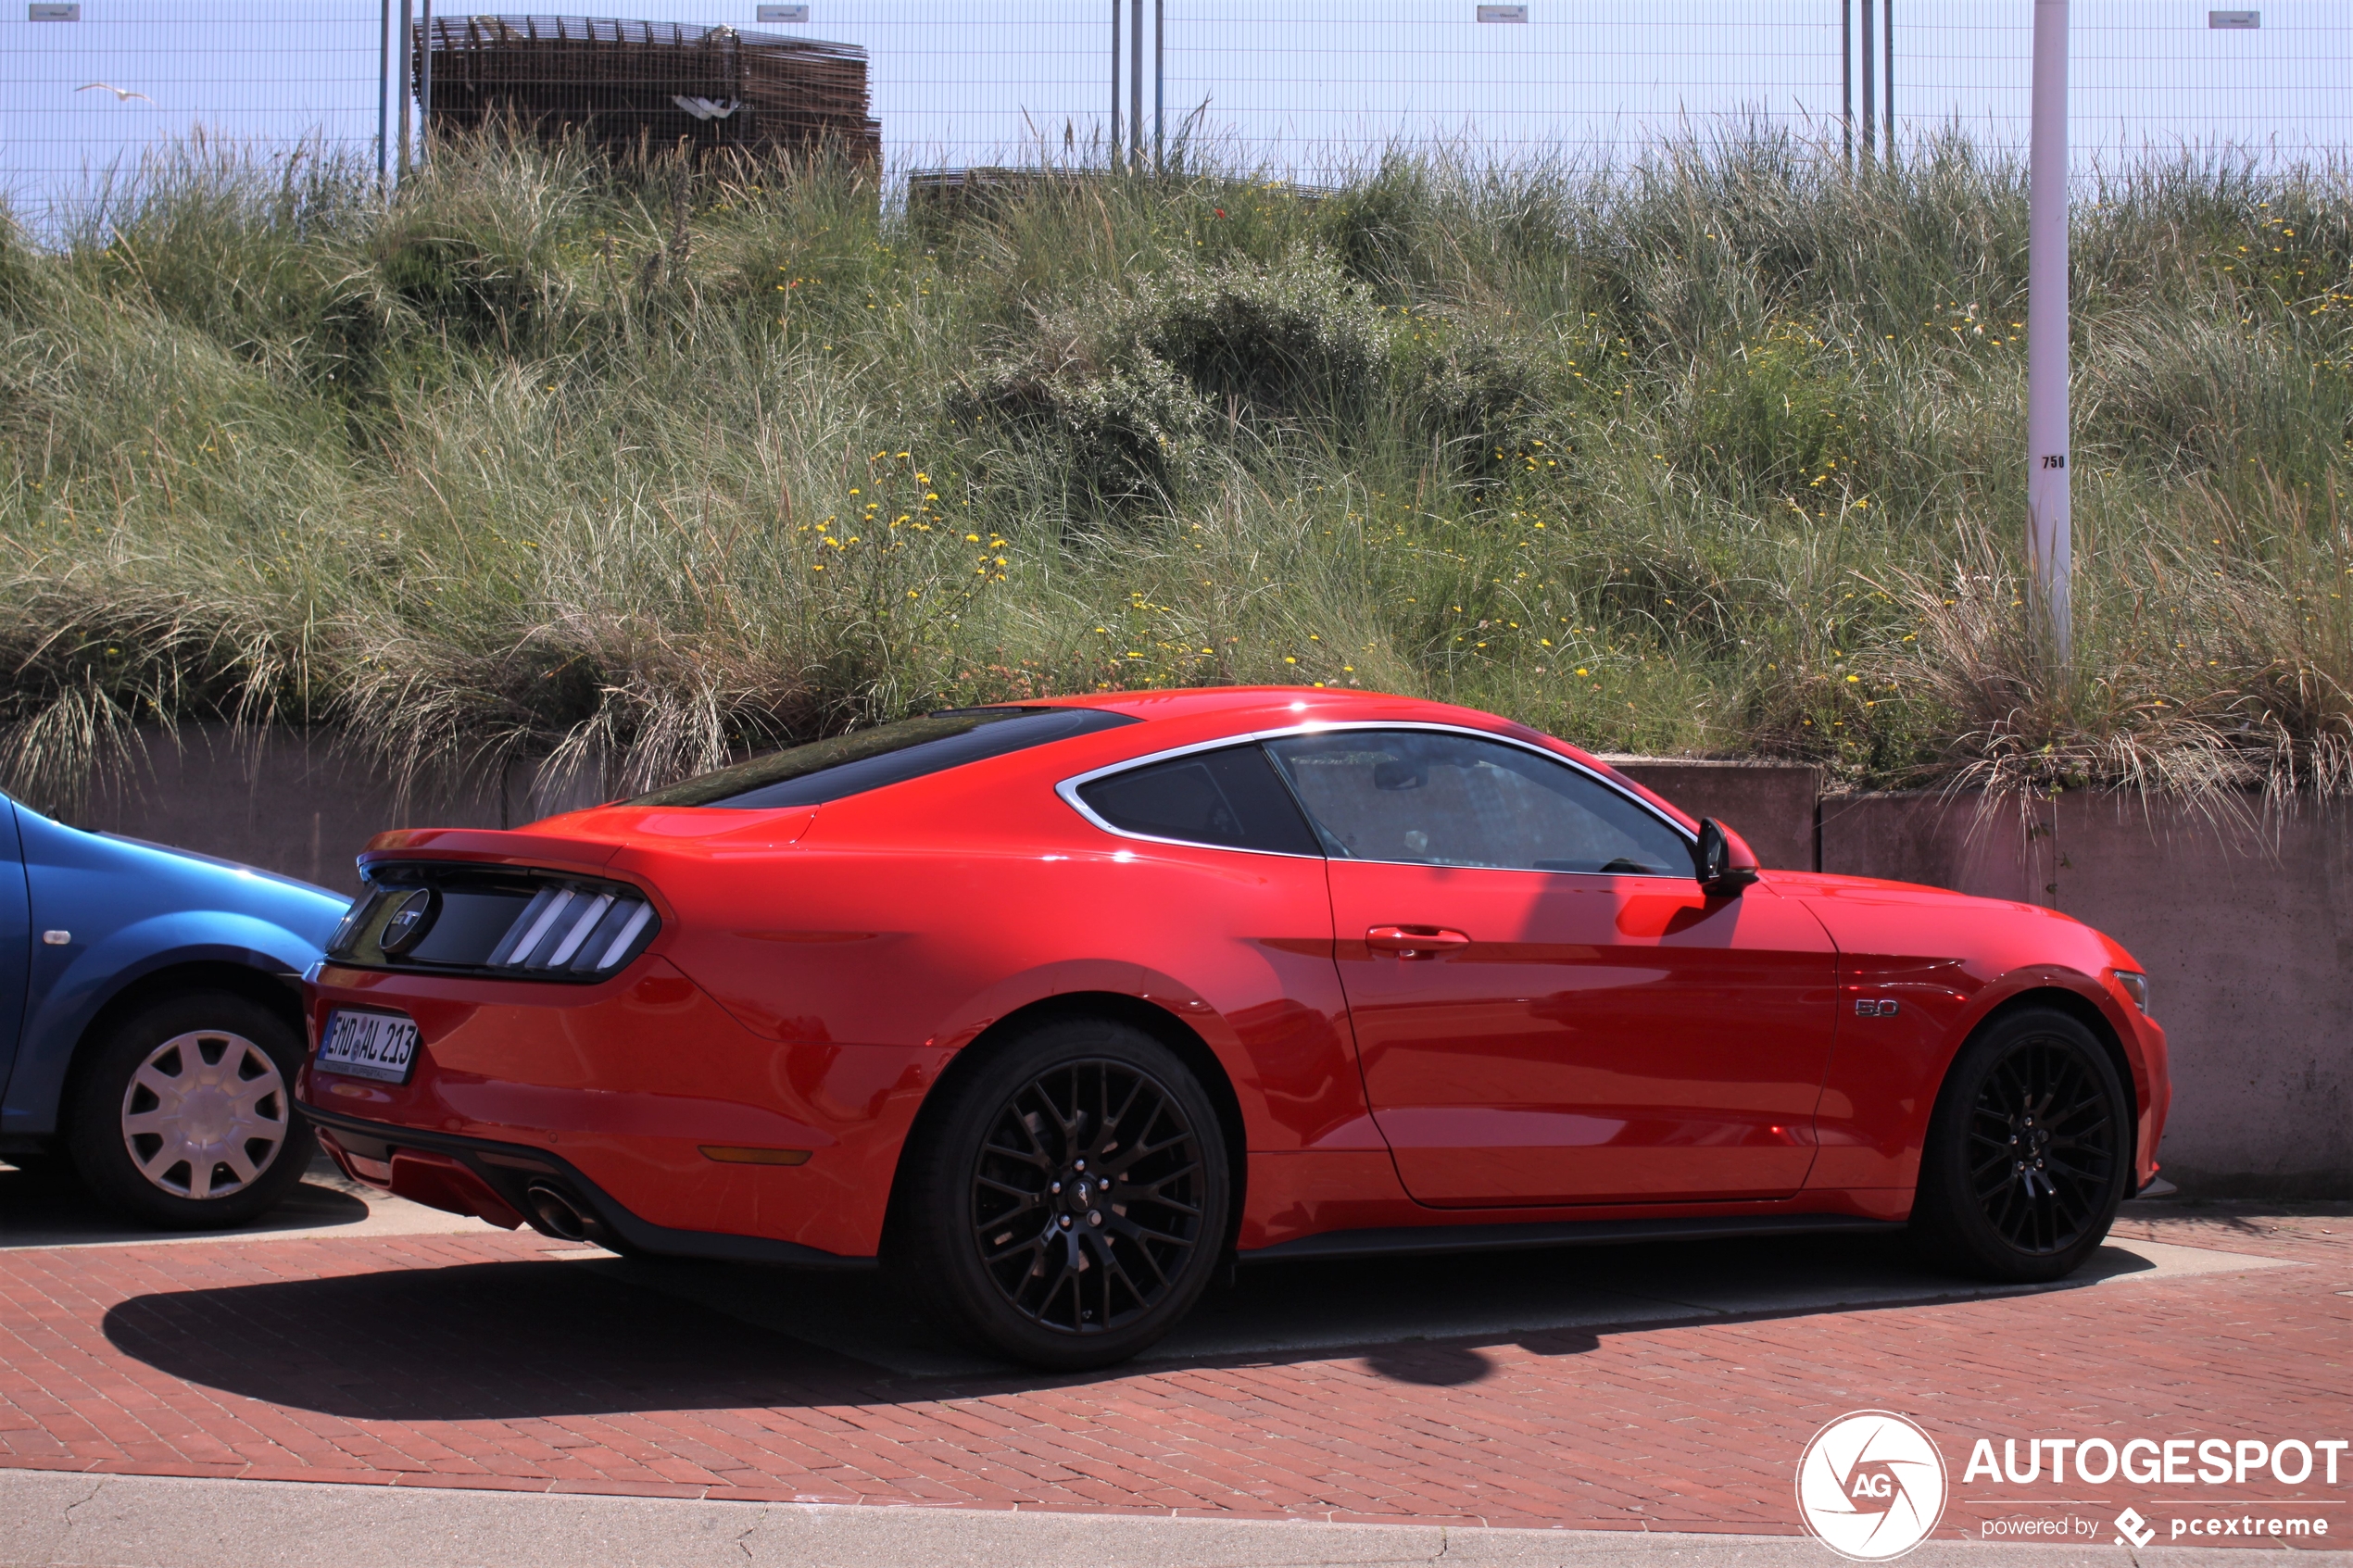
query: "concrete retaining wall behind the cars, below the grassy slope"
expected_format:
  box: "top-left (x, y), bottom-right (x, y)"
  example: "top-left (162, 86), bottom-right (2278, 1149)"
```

top-left (50, 726), bottom-right (2353, 1198)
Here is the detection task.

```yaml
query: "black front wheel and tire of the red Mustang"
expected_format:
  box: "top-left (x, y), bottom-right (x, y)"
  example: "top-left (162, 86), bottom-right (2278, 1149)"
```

top-left (1910, 1009), bottom-right (2134, 1284)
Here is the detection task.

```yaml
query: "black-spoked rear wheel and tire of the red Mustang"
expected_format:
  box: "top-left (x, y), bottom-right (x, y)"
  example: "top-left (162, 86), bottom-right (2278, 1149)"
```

top-left (889, 1018), bottom-right (1233, 1371)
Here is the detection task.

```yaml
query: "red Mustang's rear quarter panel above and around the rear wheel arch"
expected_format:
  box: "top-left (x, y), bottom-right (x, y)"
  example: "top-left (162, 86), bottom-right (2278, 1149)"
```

top-left (654, 832), bottom-right (1377, 1149)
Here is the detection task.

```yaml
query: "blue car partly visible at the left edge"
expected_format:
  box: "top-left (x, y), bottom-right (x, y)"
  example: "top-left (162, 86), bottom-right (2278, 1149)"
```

top-left (0, 797), bottom-right (350, 1229)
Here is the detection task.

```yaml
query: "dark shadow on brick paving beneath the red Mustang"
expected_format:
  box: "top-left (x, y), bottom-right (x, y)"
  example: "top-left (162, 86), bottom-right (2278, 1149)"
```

top-left (104, 1236), bottom-right (2160, 1420)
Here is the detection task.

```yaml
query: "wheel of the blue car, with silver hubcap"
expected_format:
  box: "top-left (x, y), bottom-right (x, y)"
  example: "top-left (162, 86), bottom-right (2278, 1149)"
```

top-left (70, 990), bottom-right (315, 1229)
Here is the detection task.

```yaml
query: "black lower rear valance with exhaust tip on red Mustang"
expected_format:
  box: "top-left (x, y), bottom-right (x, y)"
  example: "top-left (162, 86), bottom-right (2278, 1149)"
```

top-left (304, 1105), bottom-right (875, 1270)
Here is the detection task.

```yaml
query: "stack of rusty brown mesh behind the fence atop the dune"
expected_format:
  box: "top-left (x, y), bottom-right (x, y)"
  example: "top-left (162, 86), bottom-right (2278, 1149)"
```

top-left (412, 17), bottom-right (883, 162)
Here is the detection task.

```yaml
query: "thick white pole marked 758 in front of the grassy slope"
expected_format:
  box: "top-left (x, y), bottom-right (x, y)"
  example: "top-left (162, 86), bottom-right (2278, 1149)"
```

top-left (2026, 0), bottom-right (2075, 668)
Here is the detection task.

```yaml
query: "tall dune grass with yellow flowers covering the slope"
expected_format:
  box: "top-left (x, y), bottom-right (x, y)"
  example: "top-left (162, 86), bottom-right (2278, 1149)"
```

top-left (0, 134), bottom-right (2353, 818)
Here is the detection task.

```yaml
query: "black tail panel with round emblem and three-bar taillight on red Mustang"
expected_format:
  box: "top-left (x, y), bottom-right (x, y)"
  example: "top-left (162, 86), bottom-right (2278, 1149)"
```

top-left (327, 863), bottom-right (661, 980)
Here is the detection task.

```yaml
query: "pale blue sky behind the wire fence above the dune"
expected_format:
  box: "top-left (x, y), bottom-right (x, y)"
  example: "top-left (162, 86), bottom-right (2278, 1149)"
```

top-left (0, 0), bottom-right (2353, 211)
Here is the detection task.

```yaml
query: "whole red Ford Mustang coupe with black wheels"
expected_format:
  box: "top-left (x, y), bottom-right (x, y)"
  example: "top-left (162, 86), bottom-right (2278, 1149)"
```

top-left (299, 689), bottom-right (2170, 1368)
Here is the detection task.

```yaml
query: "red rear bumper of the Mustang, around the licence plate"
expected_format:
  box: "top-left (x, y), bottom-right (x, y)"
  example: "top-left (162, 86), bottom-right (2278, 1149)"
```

top-left (295, 955), bottom-right (953, 1258)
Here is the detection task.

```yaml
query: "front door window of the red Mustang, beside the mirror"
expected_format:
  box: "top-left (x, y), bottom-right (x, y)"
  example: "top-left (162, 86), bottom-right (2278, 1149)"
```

top-left (1266, 729), bottom-right (1692, 877)
